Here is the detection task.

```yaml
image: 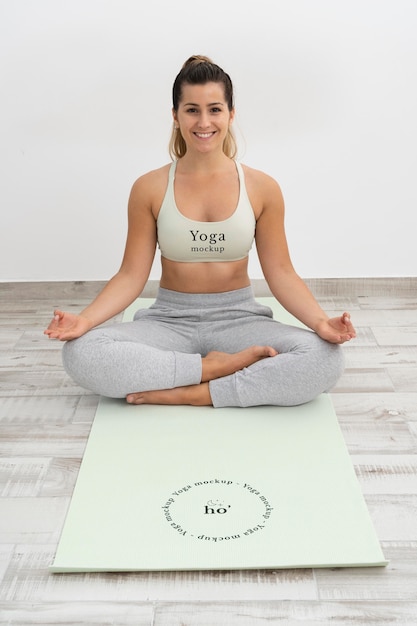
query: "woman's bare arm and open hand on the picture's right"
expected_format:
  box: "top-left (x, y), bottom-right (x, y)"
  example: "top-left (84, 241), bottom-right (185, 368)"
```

top-left (252, 173), bottom-right (355, 343)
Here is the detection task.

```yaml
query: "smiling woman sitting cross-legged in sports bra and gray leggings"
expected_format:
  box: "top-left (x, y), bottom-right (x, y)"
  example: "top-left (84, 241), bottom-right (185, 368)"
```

top-left (45, 56), bottom-right (355, 407)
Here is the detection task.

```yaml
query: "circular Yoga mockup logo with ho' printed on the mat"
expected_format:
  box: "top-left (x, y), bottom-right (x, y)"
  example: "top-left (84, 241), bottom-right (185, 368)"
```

top-left (162, 478), bottom-right (274, 543)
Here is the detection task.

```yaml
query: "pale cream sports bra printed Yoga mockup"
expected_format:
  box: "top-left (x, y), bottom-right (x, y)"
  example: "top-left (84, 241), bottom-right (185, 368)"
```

top-left (156, 161), bottom-right (256, 263)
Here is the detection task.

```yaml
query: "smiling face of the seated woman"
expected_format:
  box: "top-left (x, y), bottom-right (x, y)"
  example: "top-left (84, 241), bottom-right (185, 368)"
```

top-left (173, 82), bottom-right (234, 152)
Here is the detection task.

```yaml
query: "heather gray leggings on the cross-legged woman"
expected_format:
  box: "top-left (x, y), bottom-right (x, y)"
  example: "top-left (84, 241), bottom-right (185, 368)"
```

top-left (63, 287), bottom-right (343, 407)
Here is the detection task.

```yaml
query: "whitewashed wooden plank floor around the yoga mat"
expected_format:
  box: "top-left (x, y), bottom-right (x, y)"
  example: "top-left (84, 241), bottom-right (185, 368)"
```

top-left (0, 279), bottom-right (417, 626)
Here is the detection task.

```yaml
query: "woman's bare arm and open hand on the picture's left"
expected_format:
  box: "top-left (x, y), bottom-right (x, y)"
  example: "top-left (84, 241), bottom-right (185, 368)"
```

top-left (45, 175), bottom-right (156, 341)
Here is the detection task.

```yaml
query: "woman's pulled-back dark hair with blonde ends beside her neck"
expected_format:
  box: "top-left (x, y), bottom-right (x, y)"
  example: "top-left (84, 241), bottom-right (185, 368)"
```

top-left (169, 55), bottom-right (237, 160)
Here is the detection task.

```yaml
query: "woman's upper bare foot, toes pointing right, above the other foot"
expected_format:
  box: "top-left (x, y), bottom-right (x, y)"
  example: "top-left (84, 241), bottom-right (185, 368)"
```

top-left (201, 346), bottom-right (278, 382)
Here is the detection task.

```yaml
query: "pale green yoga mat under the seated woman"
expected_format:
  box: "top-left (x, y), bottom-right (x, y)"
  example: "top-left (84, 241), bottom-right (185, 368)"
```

top-left (50, 298), bottom-right (387, 572)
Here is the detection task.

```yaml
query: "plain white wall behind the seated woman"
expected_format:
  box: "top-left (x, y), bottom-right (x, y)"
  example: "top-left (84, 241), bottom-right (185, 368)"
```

top-left (0, 0), bottom-right (417, 281)
